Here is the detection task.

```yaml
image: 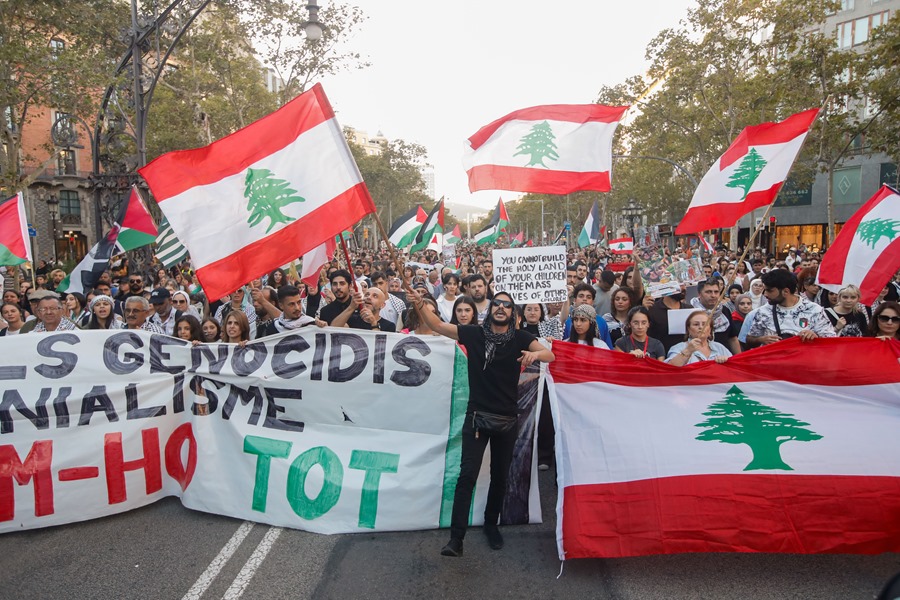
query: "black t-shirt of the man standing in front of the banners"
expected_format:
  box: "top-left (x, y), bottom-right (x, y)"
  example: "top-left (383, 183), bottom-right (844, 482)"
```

top-left (457, 325), bottom-right (537, 416)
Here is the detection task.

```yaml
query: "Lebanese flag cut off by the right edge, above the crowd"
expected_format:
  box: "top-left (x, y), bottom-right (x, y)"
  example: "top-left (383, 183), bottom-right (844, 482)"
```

top-left (816, 185), bottom-right (900, 304)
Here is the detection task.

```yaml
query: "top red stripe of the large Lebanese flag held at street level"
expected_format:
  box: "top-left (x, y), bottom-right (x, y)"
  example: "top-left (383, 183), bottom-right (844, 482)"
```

top-left (550, 337), bottom-right (900, 387)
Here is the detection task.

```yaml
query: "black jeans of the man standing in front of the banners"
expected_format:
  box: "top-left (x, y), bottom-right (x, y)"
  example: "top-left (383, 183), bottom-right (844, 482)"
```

top-left (450, 413), bottom-right (518, 539)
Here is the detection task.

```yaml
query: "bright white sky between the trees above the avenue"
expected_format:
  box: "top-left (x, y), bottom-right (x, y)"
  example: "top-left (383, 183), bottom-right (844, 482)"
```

top-left (319, 0), bottom-right (693, 216)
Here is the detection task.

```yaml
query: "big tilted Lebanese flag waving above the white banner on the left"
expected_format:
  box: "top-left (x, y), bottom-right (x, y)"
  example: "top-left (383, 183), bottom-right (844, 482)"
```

top-left (140, 84), bottom-right (375, 298)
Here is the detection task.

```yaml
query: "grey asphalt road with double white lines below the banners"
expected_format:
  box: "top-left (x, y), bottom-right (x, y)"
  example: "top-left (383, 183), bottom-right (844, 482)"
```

top-left (0, 471), bottom-right (900, 600)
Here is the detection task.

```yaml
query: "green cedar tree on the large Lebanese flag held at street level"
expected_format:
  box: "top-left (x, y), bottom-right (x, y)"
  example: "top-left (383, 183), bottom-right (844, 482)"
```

top-left (695, 385), bottom-right (822, 471)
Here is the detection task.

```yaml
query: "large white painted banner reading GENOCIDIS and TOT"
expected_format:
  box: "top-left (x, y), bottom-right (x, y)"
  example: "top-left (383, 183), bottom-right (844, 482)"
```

top-left (0, 329), bottom-right (540, 533)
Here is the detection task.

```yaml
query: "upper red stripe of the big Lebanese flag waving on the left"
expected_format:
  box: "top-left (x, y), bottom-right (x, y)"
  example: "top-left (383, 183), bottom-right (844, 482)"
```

top-left (138, 83), bottom-right (334, 200)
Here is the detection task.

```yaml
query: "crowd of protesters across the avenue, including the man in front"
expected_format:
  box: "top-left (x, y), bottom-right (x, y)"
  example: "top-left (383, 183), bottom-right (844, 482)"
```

top-left (0, 237), bottom-right (900, 556)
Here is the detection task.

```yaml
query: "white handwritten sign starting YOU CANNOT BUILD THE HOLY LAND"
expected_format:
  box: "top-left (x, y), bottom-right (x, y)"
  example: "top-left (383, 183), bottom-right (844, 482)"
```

top-left (493, 246), bottom-right (569, 304)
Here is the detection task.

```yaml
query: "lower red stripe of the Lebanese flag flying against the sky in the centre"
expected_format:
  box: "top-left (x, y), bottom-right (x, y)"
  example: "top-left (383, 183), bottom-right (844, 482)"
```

top-left (466, 165), bottom-right (610, 194)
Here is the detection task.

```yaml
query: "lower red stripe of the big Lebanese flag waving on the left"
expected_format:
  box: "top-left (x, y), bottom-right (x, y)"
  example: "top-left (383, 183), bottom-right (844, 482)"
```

top-left (196, 183), bottom-right (375, 300)
